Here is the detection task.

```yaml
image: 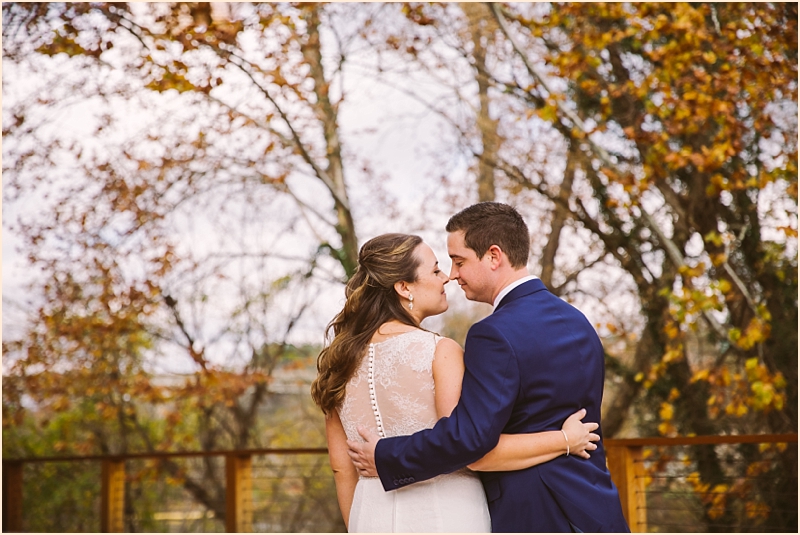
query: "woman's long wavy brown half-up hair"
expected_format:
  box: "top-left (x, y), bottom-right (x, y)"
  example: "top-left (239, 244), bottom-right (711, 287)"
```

top-left (311, 234), bottom-right (422, 415)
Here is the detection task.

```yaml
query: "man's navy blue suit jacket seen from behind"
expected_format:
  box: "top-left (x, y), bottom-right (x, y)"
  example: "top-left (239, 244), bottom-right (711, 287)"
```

top-left (375, 279), bottom-right (629, 532)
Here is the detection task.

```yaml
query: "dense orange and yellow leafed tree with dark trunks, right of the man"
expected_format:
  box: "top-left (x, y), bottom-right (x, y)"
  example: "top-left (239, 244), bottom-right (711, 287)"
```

top-left (484, 4), bottom-right (797, 525)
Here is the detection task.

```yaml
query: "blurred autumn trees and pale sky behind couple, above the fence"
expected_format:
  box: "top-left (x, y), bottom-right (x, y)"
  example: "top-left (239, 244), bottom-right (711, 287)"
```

top-left (2, 2), bottom-right (798, 531)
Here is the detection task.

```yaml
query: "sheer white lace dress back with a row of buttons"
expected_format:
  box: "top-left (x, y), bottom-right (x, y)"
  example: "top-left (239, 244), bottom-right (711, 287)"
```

top-left (339, 330), bottom-right (438, 446)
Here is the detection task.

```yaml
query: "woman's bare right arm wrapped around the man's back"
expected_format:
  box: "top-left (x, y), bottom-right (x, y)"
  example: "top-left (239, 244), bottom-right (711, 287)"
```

top-left (433, 338), bottom-right (600, 472)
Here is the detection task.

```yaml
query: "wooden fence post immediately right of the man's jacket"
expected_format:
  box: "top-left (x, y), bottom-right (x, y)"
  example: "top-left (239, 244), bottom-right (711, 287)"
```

top-left (606, 445), bottom-right (647, 533)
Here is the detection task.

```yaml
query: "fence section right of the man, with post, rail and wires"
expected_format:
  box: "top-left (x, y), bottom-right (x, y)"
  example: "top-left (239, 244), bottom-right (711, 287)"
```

top-left (604, 433), bottom-right (797, 533)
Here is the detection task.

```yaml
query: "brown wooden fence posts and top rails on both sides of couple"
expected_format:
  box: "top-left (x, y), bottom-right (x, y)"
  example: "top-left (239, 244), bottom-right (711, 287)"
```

top-left (2, 434), bottom-right (797, 533)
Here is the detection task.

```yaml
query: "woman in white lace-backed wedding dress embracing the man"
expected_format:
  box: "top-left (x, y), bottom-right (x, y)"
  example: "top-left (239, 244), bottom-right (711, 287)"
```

top-left (311, 234), bottom-right (599, 532)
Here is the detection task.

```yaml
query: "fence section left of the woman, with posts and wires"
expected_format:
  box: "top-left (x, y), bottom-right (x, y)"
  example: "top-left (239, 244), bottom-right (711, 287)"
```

top-left (3, 448), bottom-right (344, 533)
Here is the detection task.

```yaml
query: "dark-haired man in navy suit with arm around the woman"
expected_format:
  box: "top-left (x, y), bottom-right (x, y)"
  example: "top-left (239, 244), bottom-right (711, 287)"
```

top-left (348, 202), bottom-right (629, 532)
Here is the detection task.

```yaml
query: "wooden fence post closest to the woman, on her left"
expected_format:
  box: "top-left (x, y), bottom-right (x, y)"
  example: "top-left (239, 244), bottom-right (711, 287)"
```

top-left (225, 454), bottom-right (253, 533)
